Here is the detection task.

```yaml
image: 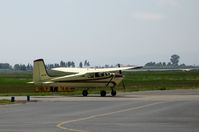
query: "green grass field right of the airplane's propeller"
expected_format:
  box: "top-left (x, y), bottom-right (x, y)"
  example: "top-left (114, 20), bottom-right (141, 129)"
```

top-left (119, 71), bottom-right (199, 91)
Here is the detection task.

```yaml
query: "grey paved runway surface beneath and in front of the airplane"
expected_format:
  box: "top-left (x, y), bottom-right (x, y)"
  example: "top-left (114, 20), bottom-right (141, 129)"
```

top-left (0, 89), bottom-right (199, 132)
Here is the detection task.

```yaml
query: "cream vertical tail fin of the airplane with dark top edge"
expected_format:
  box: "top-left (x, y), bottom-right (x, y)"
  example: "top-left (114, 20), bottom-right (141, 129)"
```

top-left (33, 59), bottom-right (51, 83)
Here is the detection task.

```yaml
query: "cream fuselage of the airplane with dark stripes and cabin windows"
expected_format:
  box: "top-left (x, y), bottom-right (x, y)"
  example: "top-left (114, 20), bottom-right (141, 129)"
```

top-left (37, 73), bottom-right (123, 88)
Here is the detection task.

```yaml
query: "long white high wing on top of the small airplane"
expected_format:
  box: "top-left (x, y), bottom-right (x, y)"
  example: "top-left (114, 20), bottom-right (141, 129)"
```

top-left (52, 66), bottom-right (142, 75)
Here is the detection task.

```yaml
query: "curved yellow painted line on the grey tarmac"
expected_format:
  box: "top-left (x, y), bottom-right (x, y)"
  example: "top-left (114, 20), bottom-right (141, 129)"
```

top-left (56, 102), bottom-right (163, 132)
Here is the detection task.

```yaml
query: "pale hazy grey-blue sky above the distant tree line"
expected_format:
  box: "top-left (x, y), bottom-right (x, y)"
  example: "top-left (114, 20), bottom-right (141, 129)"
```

top-left (0, 0), bottom-right (199, 65)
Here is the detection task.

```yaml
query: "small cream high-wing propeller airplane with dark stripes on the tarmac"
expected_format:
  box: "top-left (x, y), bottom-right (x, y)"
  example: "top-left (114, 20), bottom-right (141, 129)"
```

top-left (29, 59), bottom-right (141, 97)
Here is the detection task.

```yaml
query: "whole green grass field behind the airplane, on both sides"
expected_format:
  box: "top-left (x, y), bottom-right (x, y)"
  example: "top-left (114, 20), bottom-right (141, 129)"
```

top-left (0, 71), bottom-right (199, 96)
